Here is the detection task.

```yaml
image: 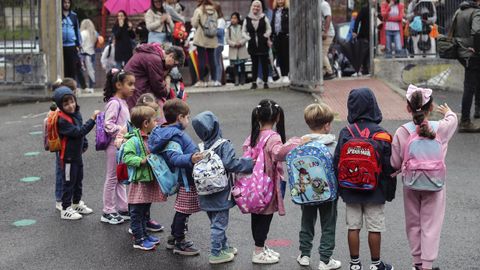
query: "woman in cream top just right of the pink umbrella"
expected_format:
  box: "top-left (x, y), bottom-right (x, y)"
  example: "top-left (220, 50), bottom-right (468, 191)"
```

top-left (145, 0), bottom-right (174, 44)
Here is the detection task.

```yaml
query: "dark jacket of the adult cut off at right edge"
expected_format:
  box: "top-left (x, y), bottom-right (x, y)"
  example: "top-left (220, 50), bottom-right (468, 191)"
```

top-left (453, 1), bottom-right (480, 58)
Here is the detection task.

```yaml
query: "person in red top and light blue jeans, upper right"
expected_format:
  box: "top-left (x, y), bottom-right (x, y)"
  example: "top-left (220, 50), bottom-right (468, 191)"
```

top-left (381, 0), bottom-right (405, 58)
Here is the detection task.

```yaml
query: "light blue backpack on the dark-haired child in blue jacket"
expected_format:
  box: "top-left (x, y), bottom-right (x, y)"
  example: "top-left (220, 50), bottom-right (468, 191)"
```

top-left (147, 141), bottom-right (190, 196)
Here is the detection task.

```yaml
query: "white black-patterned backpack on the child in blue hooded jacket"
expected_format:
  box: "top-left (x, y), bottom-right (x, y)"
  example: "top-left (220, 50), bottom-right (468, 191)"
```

top-left (193, 139), bottom-right (229, 195)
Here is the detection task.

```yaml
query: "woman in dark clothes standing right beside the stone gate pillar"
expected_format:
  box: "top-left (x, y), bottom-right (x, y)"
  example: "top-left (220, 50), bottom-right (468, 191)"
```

top-left (272, 0), bottom-right (290, 83)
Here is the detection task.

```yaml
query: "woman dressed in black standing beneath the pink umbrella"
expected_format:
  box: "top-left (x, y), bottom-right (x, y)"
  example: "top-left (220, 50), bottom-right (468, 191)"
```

top-left (112, 10), bottom-right (135, 68)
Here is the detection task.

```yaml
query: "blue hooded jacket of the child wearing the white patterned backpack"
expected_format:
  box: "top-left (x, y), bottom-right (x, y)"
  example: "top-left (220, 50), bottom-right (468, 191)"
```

top-left (192, 111), bottom-right (253, 211)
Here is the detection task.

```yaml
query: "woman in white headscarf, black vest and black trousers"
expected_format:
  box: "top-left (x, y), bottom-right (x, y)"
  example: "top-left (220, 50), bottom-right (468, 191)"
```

top-left (242, 0), bottom-right (272, 89)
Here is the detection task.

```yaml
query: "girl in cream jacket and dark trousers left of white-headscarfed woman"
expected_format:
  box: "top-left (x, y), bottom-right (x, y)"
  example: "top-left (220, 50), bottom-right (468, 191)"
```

top-left (226, 12), bottom-right (248, 86)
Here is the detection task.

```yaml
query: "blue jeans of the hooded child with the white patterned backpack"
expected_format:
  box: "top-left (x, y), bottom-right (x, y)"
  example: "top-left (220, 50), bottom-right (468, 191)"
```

top-left (207, 210), bottom-right (229, 256)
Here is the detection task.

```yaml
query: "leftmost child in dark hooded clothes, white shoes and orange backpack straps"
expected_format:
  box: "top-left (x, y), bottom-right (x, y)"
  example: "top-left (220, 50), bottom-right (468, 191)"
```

top-left (53, 86), bottom-right (100, 220)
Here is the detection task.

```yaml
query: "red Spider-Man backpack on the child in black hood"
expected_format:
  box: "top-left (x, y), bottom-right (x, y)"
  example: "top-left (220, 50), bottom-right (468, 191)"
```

top-left (338, 124), bottom-right (381, 191)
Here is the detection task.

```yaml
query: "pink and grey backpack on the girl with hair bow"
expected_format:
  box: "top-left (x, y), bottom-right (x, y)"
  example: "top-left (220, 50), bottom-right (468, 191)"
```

top-left (402, 121), bottom-right (446, 191)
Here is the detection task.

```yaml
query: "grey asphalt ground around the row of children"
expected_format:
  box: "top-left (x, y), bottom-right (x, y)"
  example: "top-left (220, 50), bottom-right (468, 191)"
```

top-left (0, 87), bottom-right (480, 270)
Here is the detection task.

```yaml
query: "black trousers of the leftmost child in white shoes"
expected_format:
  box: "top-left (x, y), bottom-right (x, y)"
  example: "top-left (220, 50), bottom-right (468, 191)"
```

top-left (62, 161), bottom-right (83, 210)
